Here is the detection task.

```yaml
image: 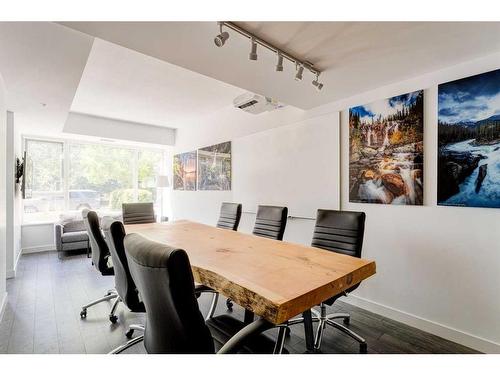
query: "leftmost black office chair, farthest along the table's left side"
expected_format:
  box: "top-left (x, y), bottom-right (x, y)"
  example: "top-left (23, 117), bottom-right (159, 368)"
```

top-left (80, 210), bottom-right (119, 323)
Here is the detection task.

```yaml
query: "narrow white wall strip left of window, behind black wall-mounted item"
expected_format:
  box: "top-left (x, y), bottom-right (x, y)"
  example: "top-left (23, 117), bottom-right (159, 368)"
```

top-left (6, 111), bottom-right (22, 278)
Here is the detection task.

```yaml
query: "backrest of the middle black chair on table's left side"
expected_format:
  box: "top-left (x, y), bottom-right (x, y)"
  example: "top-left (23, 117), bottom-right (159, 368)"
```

top-left (101, 216), bottom-right (144, 312)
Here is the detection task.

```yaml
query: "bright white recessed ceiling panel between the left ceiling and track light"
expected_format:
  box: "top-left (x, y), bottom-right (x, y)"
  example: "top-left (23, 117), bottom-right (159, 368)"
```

top-left (71, 39), bottom-right (244, 128)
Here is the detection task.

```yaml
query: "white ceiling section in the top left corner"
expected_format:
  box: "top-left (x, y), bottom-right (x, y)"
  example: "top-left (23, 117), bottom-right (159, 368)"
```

top-left (0, 22), bottom-right (93, 135)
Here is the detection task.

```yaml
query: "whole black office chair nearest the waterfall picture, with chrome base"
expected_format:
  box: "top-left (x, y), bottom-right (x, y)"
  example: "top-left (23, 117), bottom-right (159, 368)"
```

top-left (289, 210), bottom-right (367, 353)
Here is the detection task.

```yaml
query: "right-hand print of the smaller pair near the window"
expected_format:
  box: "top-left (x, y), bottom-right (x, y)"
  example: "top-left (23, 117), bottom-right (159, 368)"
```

top-left (198, 142), bottom-right (231, 190)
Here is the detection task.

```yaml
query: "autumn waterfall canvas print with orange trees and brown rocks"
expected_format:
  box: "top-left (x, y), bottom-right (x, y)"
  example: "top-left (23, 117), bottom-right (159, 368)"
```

top-left (349, 90), bottom-right (424, 205)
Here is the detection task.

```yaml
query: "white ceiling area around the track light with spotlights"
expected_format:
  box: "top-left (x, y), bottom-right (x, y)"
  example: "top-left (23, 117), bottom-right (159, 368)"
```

top-left (63, 22), bottom-right (500, 109)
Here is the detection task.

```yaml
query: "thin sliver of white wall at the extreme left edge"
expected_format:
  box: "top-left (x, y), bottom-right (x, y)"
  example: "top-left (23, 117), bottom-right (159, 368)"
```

top-left (0, 74), bottom-right (7, 319)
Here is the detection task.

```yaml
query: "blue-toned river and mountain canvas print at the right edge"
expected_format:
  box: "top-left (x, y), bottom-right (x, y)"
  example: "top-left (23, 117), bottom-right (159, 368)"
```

top-left (438, 69), bottom-right (500, 208)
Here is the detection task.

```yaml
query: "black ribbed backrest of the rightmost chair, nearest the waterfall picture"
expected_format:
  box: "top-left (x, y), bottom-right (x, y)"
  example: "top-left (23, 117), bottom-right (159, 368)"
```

top-left (311, 209), bottom-right (366, 258)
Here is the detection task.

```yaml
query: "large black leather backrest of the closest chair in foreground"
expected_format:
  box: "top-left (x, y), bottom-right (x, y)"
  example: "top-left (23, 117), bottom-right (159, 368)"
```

top-left (124, 233), bottom-right (215, 354)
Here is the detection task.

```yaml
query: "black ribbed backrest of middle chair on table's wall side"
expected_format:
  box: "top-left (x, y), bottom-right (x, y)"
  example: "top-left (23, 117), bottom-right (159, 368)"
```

top-left (252, 206), bottom-right (288, 241)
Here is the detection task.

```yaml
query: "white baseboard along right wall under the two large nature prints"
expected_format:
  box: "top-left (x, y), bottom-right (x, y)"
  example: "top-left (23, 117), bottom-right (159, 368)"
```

top-left (344, 294), bottom-right (500, 354)
